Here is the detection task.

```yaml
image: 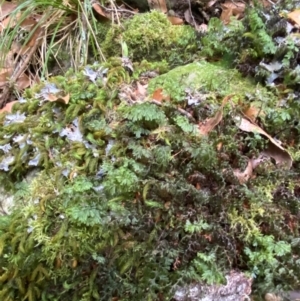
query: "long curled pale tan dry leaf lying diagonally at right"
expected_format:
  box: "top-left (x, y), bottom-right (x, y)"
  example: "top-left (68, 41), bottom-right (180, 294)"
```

top-left (235, 116), bottom-right (293, 168)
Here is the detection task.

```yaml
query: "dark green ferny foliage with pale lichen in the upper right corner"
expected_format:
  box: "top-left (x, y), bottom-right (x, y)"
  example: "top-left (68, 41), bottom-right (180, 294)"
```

top-left (201, 1), bottom-right (299, 89)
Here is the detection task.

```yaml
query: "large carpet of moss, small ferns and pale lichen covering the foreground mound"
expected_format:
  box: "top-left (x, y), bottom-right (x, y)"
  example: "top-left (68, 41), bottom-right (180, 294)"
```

top-left (0, 58), bottom-right (300, 301)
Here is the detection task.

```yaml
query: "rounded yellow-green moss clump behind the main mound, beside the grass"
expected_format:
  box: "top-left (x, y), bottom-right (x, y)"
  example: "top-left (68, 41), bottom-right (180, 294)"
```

top-left (101, 10), bottom-right (198, 65)
